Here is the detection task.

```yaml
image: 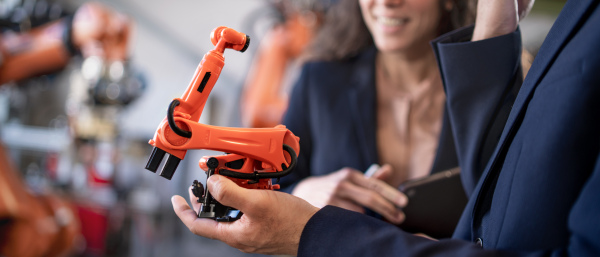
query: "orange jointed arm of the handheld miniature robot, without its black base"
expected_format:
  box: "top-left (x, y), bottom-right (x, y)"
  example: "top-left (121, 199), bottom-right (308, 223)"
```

top-left (146, 27), bottom-right (300, 179)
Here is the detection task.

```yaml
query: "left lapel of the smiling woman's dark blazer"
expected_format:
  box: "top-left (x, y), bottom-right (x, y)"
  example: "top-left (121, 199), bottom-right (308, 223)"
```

top-left (347, 47), bottom-right (378, 165)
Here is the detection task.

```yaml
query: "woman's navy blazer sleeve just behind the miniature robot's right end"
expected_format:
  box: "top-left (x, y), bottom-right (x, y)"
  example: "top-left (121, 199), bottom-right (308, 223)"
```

top-left (279, 64), bottom-right (312, 193)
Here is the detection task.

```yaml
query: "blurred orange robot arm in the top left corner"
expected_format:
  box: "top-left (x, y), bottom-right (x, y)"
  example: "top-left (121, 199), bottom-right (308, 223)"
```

top-left (0, 2), bottom-right (131, 85)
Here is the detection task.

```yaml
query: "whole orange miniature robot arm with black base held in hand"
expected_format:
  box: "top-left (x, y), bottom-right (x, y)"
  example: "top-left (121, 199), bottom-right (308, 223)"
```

top-left (146, 27), bottom-right (300, 221)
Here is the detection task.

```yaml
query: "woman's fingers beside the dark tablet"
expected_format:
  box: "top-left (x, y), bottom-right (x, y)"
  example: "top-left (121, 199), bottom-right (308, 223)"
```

top-left (338, 181), bottom-right (404, 224)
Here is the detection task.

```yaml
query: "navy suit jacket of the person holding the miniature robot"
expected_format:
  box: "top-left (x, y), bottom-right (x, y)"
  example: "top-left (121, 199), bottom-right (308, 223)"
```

top-left (299, 0), bottom-right (600, 256)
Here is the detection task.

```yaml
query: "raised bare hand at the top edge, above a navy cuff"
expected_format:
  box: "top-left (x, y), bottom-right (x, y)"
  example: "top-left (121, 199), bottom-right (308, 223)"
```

top-left (472, 0), bottom-right (535, 41)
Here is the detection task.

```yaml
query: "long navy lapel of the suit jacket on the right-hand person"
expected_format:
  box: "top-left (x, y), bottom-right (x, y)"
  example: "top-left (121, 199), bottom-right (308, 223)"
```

top-left (471, 0), bottom-right (594, 241)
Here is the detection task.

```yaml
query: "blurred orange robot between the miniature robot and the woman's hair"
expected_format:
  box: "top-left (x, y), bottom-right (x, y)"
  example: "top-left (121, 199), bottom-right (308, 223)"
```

top-left (240, 0), bottom-right (325, 128)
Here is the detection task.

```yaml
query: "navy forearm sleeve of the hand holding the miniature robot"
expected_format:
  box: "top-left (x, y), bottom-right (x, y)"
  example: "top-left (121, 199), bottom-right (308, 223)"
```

top-left (298, 206), bottom-right (500, 257)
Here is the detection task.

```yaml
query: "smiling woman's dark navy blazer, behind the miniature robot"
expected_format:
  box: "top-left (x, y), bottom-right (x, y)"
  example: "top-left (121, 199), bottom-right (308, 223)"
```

top-left (279, 47), bottom-right (462, 192)
